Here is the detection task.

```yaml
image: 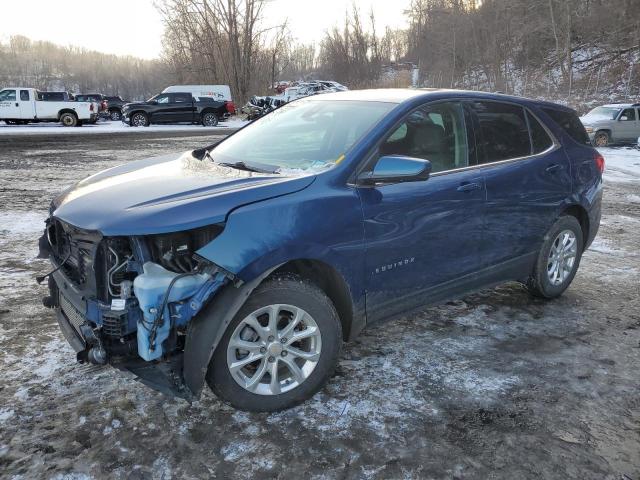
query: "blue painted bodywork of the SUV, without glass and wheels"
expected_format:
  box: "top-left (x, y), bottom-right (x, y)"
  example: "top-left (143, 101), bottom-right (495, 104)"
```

top-left (45, 90), bottom-right (602, 383)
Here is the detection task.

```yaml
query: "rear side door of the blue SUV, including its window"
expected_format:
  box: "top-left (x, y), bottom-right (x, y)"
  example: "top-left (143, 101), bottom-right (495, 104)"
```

top-left (468, 100), bottom-right (571, 270)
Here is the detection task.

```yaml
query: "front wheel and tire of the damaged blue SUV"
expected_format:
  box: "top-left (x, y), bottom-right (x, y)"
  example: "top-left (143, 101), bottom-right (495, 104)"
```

top-left (207, 275), bottom-right (342, 412)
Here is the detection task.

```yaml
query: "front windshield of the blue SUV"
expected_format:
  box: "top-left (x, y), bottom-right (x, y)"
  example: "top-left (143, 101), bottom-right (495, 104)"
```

top-left (211, 100), bottom-right (396, 171)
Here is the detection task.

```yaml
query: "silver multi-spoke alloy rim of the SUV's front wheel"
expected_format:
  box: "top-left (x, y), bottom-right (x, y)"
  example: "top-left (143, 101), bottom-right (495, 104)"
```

top-left (227, 304), bottom-right (322, 395)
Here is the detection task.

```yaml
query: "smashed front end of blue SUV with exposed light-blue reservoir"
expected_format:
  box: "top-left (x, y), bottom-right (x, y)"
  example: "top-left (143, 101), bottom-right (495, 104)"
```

top-left (40, 216), bottom-right (235, 398)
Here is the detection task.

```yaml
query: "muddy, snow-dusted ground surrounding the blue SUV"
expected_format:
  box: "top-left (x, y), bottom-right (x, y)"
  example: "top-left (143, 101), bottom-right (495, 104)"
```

top-left (0, 134), bottom-right (640, 480)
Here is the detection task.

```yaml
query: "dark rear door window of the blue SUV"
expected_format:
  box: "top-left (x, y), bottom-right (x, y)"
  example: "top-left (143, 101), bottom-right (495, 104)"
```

top-left (470, 101), bottom-right (531, 163)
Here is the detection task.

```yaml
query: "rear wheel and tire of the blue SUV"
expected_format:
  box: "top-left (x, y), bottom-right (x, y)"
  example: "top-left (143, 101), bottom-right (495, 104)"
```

top-left (527, 216), bottom-right (584, 299)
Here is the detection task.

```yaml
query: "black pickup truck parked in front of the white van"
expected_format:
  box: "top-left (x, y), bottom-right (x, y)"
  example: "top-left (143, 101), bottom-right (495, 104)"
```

top-left (122, 92), bottom-right (229, 127)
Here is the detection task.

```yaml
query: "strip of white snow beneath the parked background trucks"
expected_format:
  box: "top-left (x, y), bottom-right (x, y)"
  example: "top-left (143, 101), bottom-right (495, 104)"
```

top-left (0, 118), bottom-right (248, 135)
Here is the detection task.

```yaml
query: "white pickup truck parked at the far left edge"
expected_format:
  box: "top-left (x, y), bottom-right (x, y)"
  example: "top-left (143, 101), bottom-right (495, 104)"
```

top-left (0, 87), bottom-right (98, 127)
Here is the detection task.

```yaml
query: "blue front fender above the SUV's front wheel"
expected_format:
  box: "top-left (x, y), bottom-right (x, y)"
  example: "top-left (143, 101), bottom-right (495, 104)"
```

top-left (197, 185), bottom-right (364, 284)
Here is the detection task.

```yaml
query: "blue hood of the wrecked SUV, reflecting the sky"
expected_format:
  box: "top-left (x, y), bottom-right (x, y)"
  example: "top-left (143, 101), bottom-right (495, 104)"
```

top-left (52, 148), bottom-right (315, 236)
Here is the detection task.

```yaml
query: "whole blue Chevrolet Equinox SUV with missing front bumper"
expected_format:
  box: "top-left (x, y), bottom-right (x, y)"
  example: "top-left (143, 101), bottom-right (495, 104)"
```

top-left (40, 90), bottom-right (604, 411)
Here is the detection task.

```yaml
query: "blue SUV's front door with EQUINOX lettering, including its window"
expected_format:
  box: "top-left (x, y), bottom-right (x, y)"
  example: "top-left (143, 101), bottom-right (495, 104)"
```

top-left (358, 102), bottom-right (485, 321)
